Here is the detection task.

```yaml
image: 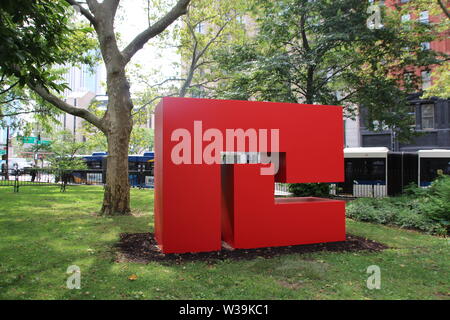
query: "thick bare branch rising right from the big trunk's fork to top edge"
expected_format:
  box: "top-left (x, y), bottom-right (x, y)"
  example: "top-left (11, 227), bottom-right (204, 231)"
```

top-left (122, 0), bottom-right (191, 63)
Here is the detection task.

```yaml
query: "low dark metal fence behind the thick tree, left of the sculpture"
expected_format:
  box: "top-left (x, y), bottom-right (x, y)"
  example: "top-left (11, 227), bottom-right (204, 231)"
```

top-left (0, 169), bottom-right (154, 192)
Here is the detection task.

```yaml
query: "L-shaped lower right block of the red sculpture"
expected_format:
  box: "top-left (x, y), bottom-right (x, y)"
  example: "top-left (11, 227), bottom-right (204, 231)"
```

top-left (222, 164), bottom-right (345, 249)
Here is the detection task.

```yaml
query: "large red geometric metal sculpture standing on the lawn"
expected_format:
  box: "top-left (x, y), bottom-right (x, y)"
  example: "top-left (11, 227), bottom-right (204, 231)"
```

top-left (154, 98), bottom-right (345, 253)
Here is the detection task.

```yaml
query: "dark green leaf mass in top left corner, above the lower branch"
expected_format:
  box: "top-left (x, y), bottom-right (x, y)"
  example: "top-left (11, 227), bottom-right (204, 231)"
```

top-left (0, 0), bottom-right (95, 91)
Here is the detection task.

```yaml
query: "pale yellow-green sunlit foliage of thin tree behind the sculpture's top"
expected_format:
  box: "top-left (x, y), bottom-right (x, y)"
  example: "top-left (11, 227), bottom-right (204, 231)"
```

top-left (132, 0), bottom-right (254, 106)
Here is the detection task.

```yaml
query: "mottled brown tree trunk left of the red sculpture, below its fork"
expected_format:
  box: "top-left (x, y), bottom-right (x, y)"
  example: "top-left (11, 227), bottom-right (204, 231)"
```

top-left (101, 70), bottom-right (133, 215)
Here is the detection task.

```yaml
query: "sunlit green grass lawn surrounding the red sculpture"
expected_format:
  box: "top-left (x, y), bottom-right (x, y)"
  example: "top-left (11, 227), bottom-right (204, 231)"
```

top-left (0, 186), bottom-right (450, 299)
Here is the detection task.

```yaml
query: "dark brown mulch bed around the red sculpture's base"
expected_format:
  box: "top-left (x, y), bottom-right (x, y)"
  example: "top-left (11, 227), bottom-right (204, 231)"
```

top-left (115, 233), bottom-right (388, 264)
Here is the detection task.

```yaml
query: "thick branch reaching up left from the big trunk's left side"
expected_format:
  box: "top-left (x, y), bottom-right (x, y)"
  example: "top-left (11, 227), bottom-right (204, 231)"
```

top-left (28, 84), bottom-right (107, 133)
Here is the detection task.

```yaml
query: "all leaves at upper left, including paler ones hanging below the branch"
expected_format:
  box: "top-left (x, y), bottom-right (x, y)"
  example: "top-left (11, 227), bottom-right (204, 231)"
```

top-left (0, 0), bottom-right (98, 129)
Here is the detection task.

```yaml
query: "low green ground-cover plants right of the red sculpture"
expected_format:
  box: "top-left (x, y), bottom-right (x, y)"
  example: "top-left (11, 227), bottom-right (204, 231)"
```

top-left (347, 176), bottom-right (450, 235)
